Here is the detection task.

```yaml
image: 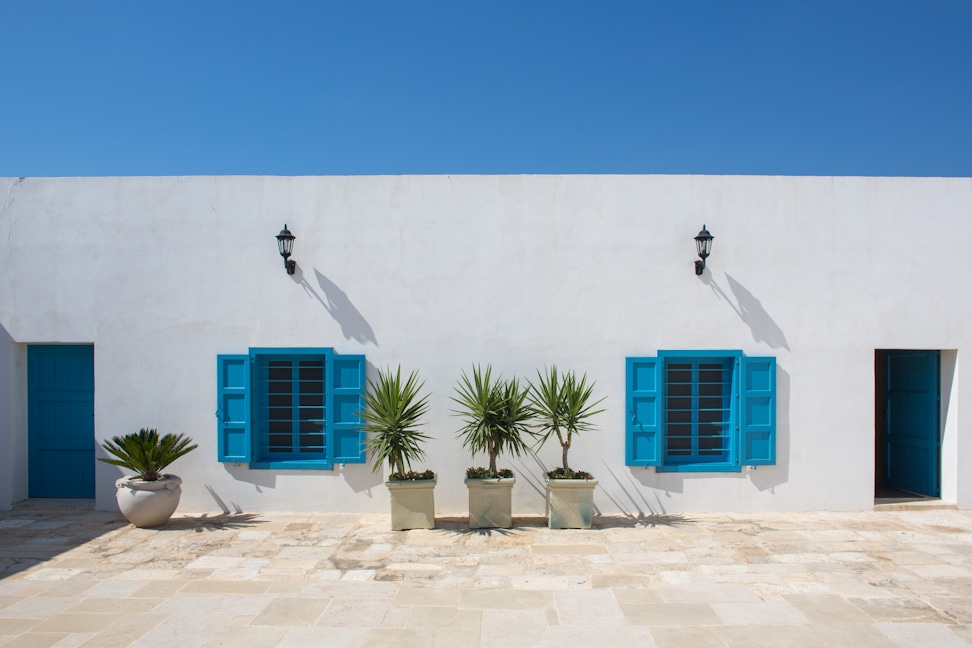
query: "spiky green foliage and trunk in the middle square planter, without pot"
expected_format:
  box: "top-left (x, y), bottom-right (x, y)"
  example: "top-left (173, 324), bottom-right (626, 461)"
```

top-left (452, 365), bottom-right (533, 477)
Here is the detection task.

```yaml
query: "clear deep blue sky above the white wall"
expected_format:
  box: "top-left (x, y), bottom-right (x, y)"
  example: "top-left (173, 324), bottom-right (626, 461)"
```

top-left (0, 0), bottom-right (972, 177)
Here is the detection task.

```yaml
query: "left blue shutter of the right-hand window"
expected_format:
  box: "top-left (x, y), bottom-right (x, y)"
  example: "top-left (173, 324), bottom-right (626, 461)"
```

top-left (625, 358), bottom-right (663, 466)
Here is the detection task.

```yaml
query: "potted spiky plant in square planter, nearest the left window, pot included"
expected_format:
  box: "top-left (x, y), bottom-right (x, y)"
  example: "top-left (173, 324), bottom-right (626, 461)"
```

top-left (360, 367), bottom-right (436, 531)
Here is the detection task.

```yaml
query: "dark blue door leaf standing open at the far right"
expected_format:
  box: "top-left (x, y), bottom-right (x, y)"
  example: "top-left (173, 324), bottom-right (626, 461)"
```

top-left (885, 351), bottom-right (940, 497)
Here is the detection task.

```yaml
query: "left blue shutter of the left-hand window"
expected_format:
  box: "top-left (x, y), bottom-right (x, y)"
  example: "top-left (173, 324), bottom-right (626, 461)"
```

top-left (216, 355), bottom-right (252, 462)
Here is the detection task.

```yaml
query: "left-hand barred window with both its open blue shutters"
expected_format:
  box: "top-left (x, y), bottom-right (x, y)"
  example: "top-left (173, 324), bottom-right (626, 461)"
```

top-left (216, 349), bottom-right (365, 470)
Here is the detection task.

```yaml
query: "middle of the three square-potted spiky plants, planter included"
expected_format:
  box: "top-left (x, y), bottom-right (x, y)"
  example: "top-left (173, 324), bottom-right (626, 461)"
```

top-left (452, 366), bottom-right (533, 529)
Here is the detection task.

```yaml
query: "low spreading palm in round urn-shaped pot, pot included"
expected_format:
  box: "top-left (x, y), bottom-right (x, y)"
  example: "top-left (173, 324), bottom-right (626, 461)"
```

top-left (99, 428), bottom-right (198, 528)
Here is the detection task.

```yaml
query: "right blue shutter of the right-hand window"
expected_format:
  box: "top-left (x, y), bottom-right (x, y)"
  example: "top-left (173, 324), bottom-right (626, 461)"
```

top-left (738, 357), bottom-right (776, 466)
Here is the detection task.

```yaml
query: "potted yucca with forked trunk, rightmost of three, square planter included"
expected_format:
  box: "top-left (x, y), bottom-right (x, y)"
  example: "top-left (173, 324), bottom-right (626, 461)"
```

top-left (529, 365), bottom-right (604, 529)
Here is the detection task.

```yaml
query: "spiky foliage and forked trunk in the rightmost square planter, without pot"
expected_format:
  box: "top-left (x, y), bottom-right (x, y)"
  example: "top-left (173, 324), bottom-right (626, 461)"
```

top-left (529, 365), bottom-right (604, 477)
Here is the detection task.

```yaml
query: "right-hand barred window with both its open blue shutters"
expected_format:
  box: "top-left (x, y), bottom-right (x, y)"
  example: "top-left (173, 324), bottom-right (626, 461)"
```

top-left (626, 351), bottom-right (776, 472)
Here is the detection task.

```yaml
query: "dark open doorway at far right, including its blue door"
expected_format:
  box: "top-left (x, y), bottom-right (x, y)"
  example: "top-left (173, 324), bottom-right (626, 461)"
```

top-left (874, 349), bottom-right (941, 498)
